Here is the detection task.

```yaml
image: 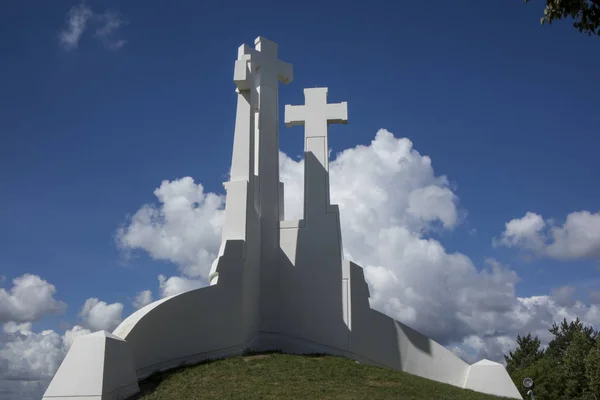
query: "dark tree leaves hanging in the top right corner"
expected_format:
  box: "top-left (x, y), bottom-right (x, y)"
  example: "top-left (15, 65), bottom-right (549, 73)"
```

top-left (525, 0), bottom-right (600, 35)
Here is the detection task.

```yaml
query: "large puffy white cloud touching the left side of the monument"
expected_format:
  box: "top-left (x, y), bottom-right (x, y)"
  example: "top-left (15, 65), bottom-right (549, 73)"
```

top-left (117, 177), bottom-right (224, 281)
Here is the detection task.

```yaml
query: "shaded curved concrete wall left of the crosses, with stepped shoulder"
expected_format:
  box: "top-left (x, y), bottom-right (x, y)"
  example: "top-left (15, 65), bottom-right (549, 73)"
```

top-left (114, 241), bottom-right (250, 378)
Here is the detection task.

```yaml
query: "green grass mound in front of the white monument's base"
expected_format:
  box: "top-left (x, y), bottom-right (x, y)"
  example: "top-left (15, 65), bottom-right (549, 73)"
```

top-left (134, 353), bottom-right (516, 400)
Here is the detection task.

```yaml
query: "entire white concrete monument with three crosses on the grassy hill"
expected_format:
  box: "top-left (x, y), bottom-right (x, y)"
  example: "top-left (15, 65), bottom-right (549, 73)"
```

top-left (44, 37), bottom-right (521, 400)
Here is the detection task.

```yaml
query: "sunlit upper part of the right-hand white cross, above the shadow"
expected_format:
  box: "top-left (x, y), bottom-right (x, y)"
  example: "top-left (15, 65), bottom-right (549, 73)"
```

top-left (285, 88), bottom-right (348, 171)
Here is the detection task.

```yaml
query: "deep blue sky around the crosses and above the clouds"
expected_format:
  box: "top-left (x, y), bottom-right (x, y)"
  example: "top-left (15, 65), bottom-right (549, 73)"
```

top-left (0, 0), bottom-right (600, 356)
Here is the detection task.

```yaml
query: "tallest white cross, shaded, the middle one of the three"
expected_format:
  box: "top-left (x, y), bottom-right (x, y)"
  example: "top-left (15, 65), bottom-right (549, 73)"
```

top-left (236, 37), bottom-right (293, 332)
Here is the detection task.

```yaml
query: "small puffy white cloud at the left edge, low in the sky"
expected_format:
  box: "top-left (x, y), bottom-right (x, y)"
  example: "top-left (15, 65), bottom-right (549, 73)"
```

top-left (0, 274), bottom-right (67, 323)
